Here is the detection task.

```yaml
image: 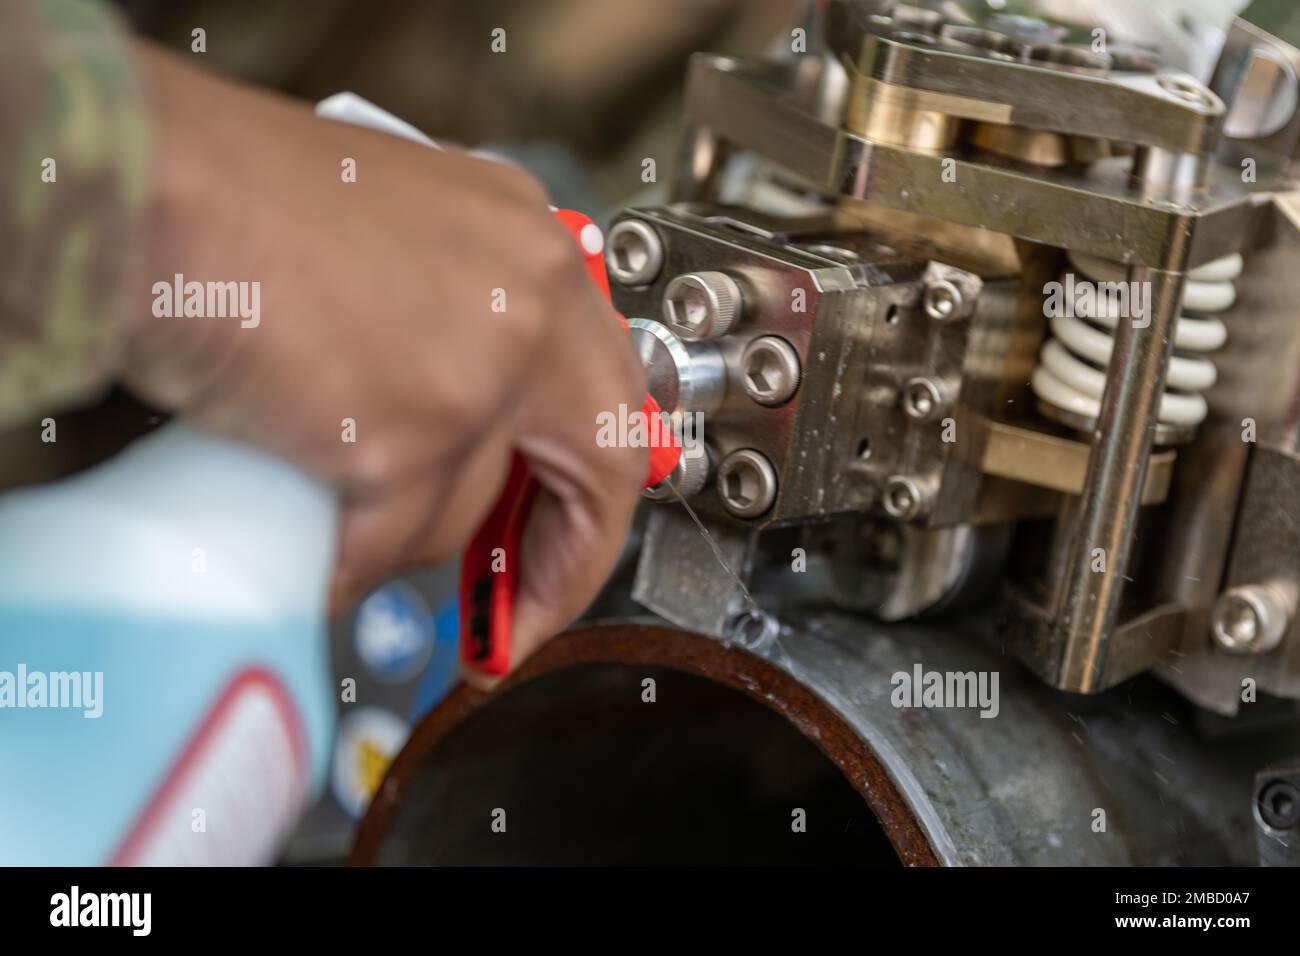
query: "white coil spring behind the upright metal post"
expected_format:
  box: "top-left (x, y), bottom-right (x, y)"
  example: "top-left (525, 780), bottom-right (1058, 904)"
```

top-left (1030, 252), bottom-right (1242, 427)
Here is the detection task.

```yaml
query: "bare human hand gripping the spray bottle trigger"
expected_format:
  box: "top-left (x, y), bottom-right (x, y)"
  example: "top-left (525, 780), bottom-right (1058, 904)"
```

top-left (125, 42), bottom-right (645, 661)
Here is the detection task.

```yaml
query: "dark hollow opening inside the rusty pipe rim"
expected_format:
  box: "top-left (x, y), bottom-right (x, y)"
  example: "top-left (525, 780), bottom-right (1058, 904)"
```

top-left (373, 663), bottom-right (898, 866)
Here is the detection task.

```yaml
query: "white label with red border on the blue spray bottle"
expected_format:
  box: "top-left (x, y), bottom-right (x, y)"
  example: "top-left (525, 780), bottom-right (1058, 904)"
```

top-left (111, 667), bottom-right (309, 866)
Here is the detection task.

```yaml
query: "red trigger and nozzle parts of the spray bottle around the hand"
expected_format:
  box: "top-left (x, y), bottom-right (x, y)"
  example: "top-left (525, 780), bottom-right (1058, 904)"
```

top-left (460, 209), bottom-right (681, 676)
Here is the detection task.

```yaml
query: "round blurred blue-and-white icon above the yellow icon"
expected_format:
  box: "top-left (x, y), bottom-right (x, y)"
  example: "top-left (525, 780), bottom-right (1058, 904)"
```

top-left (352, 581), bottom-right (434, 683)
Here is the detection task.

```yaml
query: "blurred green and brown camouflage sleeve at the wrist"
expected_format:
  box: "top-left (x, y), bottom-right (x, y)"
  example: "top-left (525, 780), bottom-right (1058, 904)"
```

top-left (0, 0), bottom-right (150, 425)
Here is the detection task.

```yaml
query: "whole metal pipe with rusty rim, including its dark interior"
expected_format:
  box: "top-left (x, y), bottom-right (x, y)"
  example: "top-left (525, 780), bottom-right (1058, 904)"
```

top-left (352, 614), bottom-right (1279, 865)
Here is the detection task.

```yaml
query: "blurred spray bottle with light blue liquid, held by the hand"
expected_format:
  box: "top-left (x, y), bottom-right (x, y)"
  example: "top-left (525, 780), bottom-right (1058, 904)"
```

top-left (0, 94), bottom-right (437, 865)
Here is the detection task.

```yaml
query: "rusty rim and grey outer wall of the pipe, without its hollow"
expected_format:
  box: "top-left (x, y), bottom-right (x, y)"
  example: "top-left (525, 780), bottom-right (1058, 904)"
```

top-left (350, 614), bottom-right (1300, 866)
